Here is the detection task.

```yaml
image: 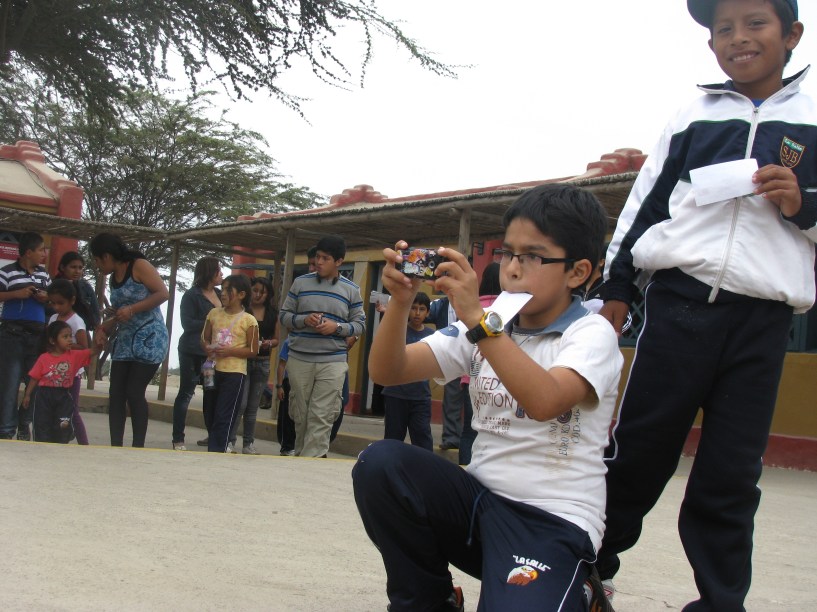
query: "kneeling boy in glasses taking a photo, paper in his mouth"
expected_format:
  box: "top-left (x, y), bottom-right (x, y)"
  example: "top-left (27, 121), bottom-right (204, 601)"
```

top-left (352, 185), bottom-right (623, 612)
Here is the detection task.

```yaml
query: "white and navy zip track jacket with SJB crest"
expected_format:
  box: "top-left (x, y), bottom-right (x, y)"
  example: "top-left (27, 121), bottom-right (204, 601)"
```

top-left (602, 68), bottom-right (817, 312)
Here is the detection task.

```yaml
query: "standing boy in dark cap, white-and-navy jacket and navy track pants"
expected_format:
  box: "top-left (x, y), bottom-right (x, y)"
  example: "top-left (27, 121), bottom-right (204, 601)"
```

top-left (597, 0), bottom-right (817, 612)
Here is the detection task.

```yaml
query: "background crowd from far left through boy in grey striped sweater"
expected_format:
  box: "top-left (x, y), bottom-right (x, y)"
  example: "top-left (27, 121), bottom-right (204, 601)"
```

top-left (0, 233), bottom-right (380, 456)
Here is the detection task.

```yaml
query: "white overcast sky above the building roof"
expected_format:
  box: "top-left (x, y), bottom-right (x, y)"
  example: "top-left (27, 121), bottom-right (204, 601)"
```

top-left (212, 0), bottom-right (817, 197)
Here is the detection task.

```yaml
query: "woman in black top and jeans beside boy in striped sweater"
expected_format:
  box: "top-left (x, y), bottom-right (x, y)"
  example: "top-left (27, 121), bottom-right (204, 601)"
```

top-left (228, 276), bottom-right (278, 455)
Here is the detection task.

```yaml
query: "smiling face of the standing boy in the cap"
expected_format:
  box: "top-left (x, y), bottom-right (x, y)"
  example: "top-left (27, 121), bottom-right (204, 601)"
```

top-left (709, 0), bottom-right (803, 100)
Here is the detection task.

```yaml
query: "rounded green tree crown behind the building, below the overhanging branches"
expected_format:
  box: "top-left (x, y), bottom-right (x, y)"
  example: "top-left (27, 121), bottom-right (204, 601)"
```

top-left (0, 81), bottom-right (320, 274)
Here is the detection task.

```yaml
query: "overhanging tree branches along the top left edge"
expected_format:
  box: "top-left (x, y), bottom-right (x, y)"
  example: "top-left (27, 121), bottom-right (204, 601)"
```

top-left (0, 0), bottom-right (453, 114)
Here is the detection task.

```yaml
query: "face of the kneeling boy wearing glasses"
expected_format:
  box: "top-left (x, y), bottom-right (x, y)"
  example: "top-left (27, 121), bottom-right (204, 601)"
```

top-left (499, 217), bottom-right (592, 329)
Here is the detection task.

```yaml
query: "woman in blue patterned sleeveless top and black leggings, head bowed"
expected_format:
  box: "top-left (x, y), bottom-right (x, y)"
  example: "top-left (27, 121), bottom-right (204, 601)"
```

top-left (90, 233), bottom-right (169, 447)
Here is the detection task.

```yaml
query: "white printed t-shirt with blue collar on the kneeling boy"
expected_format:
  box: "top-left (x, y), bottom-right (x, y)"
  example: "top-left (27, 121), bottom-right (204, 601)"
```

top-left (422, 300), bottom-right (624, 550)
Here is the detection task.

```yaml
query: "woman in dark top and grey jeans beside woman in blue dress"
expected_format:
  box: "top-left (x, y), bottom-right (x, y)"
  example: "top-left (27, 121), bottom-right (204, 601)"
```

top-left (172, 257), bottom-right (222, 450)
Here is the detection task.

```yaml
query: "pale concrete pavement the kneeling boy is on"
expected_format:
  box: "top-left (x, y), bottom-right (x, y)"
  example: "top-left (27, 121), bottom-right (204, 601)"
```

top-left (0, 382), bottom-right (817, 612)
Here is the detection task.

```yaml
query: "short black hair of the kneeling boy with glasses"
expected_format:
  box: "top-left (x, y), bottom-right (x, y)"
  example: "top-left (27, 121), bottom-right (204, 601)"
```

top-left (502, 183), bottom-right (608, 270)
